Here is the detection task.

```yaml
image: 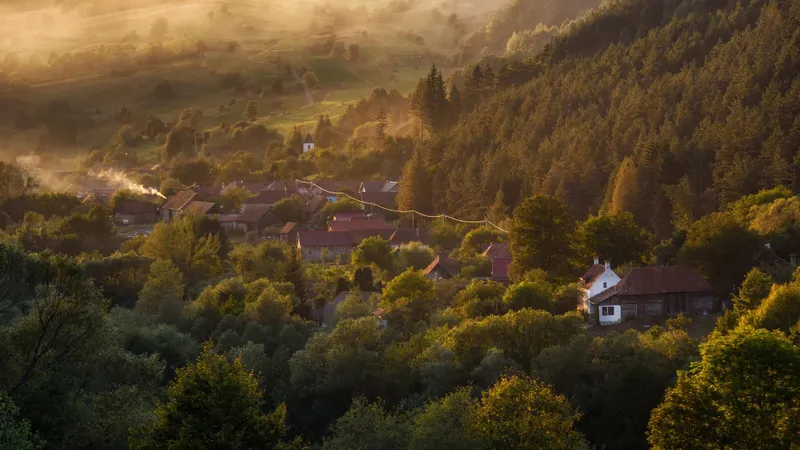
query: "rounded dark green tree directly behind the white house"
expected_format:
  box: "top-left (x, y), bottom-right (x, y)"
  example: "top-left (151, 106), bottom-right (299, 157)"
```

top-left (575, 213), bottom-right (649, 266)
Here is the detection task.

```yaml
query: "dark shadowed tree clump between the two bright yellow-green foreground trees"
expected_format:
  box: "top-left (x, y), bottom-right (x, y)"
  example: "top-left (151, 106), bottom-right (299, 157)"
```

top-left (534, 330), bottom-right (697, 449)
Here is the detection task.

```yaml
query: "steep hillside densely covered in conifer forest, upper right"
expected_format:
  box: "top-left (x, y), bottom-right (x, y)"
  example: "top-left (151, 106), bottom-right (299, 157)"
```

top-left (430, 0), bottom-right (800, 235)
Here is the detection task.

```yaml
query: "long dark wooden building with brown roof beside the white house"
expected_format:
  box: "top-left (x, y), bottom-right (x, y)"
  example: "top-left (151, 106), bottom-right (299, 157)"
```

top-left (589, 266), bottom-right (720, 325)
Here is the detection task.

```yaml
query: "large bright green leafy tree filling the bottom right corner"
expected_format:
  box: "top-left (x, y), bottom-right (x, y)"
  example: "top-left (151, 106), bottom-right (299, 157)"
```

top-left (648, 327), bottom-right (800, 449)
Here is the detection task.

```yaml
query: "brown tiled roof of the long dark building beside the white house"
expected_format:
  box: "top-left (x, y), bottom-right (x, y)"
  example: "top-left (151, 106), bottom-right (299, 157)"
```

top-left (592, 266), bottom-right (714, 304)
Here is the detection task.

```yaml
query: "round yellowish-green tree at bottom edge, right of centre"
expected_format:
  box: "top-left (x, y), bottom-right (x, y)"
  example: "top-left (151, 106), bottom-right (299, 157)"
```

top-left (475, 376), bottom-right (589, 450)
